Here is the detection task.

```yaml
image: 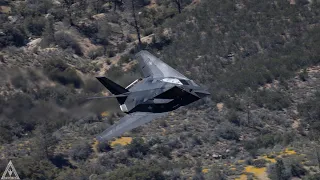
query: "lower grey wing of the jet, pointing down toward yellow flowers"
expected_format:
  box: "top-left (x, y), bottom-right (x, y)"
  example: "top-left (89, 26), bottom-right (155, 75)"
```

top-left (97, 112), bottom-right (167, 141)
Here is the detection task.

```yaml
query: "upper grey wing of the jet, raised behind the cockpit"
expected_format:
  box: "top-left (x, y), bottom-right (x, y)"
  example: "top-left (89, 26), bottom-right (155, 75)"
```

top-left (136, 50), bottom-right (188, 80)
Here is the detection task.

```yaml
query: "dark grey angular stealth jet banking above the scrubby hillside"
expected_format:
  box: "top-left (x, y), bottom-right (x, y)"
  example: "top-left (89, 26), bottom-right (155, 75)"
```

top-left (92, 50), bottom-right (210, 141)
